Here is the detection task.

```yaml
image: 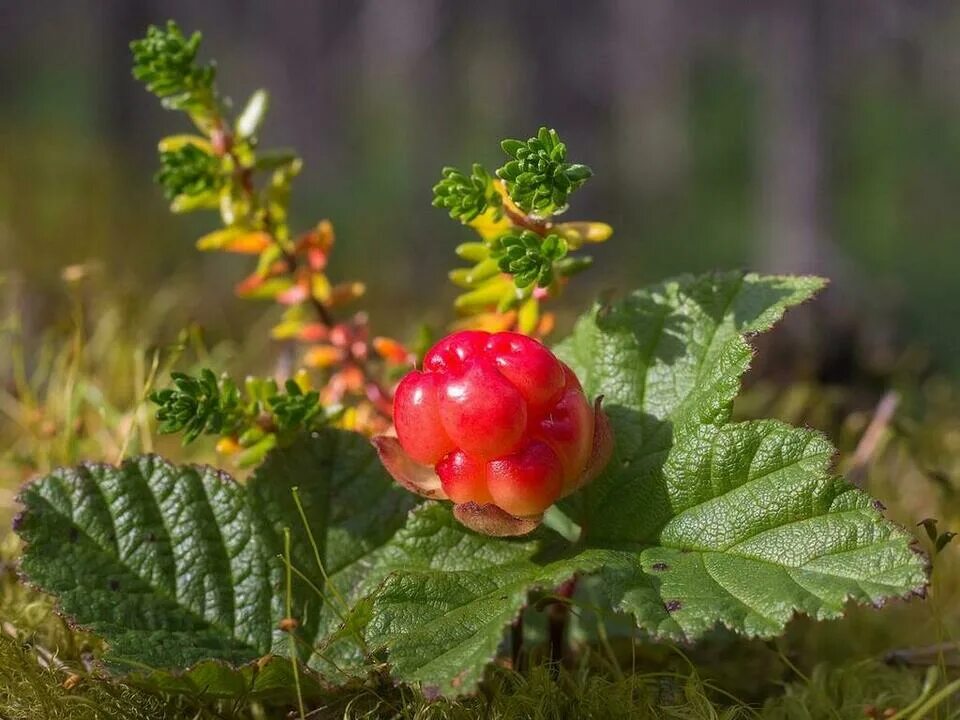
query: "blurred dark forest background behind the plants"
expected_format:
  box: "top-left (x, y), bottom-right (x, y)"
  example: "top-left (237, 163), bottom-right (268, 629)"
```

top-left (0, 0), bottom-right (960, 373)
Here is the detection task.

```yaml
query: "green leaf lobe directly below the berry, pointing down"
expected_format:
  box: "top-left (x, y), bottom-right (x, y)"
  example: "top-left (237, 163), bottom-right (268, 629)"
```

top-left (356, 502), bottom-right (605, 693)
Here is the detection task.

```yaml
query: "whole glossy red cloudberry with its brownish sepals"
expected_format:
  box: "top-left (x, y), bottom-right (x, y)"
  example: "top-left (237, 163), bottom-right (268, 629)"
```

top-left (376, 330), bottom-right (609, 534)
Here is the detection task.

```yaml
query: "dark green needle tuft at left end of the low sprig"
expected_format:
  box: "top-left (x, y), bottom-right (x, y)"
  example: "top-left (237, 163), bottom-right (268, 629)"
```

top-left (150, 368), bottom-right (246, 443)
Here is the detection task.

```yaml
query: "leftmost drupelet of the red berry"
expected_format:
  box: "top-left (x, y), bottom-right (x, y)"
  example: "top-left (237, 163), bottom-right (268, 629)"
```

top-left (393, 371), bottom-right (456, 465)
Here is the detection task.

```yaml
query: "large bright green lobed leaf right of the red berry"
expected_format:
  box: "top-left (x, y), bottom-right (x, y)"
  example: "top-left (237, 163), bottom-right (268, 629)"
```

top-left (558, 273), bottom-right (926, 639)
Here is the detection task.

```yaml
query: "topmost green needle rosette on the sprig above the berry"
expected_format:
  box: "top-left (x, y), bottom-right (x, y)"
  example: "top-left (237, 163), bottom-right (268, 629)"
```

top-left (497, 127), bottom-right (593, 217)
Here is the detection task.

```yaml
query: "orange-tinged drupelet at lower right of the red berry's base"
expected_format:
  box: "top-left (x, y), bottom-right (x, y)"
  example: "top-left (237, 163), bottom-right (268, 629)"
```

top-left (487, 441), bottom-right (563, 517)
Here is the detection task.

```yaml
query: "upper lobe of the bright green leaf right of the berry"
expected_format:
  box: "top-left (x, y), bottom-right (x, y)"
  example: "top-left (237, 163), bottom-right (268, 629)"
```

top-left (556, 272), bottom-right (824, 428)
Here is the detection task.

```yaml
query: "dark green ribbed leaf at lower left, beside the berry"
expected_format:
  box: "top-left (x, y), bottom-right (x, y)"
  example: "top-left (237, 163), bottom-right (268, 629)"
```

top-left (17, 430), bottom-right (413, 684)
